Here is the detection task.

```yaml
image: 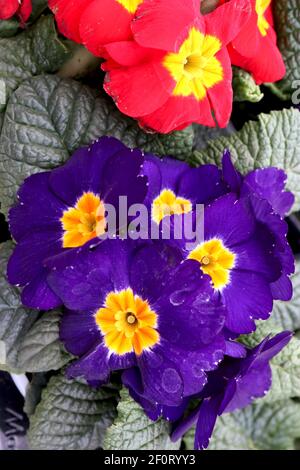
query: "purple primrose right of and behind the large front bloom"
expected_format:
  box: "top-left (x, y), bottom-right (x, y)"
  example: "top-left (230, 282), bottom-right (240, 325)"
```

top-left (161, 153), bottom-right (294, 337)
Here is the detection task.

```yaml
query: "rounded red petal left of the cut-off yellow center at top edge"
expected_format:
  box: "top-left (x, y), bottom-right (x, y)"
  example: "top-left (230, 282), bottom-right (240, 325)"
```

top-left (80, 0), bottom-right (133, 55)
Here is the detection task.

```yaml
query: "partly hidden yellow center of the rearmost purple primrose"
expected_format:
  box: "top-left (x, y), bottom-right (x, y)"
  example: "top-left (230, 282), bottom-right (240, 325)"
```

top-left (152, 189), bottom-right (192, 224)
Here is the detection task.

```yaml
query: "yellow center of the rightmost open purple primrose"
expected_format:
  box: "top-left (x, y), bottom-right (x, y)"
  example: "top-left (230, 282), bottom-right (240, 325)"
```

top-left (188, 239), bottom-right (235, 289)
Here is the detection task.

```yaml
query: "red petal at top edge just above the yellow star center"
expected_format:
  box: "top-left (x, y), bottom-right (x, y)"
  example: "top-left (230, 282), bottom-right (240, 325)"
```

top-left (131, 0), bottom-right (200, 52)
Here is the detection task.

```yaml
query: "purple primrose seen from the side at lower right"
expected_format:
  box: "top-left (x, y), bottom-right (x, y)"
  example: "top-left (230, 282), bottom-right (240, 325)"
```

top-left (172, 331), bottom-right (292, 449)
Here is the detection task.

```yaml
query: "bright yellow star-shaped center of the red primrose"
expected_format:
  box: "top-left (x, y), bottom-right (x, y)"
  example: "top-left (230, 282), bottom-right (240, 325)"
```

top-left (163, 27), bottom-right (224, 101)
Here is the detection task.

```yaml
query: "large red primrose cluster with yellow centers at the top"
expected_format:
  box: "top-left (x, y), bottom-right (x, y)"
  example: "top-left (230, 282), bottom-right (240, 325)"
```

top-left (49, 0), bottom-right (282, 133)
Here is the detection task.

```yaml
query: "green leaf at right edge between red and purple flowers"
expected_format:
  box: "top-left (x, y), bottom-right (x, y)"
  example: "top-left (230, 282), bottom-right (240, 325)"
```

top-left (190, 109), bottom-right (300, 211)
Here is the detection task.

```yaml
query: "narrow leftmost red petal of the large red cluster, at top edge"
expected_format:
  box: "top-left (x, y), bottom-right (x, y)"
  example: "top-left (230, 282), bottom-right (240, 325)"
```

top-left (49, 0), bottom-right (93, 43)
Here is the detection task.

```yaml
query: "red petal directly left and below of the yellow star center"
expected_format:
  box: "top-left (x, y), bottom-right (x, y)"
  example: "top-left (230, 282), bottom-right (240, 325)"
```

top-left (104, 52), bottom-right (175, 117)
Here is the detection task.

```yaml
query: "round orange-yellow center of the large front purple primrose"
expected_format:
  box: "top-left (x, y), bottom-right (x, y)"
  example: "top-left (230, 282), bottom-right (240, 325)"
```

top-left (95, 288), bottom-right (159, 356)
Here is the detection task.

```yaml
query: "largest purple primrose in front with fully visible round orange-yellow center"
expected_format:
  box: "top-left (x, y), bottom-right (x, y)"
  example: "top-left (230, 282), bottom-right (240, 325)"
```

top-left (48, 240), bottom-right (226, 406)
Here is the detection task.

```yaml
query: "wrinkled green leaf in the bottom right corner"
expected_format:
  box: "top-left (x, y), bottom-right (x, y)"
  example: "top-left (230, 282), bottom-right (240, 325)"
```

top-left (209, 400), bottom-right (300, 450)
